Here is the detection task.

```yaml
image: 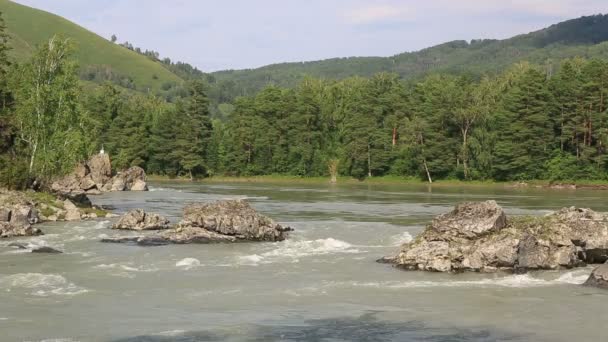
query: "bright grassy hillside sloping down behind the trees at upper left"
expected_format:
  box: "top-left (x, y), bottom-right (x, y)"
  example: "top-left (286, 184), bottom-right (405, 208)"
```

top-left (0, 0), bottom-right (182, 90)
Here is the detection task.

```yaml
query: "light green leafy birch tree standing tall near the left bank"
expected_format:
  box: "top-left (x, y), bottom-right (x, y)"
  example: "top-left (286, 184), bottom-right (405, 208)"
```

top-left (11, 36), bottom-right (89, 179)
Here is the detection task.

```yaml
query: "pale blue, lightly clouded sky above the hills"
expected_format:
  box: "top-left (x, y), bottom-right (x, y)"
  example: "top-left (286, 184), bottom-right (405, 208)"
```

top-left (16, 0), bottom-right (608, 71)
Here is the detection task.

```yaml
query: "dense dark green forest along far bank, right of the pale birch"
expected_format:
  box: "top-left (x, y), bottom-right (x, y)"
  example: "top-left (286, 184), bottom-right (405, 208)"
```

top-left (87, 59), bottom-right (608, 181)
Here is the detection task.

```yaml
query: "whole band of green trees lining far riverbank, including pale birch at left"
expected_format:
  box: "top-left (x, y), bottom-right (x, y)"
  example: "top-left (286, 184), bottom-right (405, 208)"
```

top-left (0, 11), bottom-right (608, 188)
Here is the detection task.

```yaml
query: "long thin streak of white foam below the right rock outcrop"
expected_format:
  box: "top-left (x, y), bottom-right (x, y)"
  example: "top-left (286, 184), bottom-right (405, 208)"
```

top-left (340, 269), bottom-right (590, 289)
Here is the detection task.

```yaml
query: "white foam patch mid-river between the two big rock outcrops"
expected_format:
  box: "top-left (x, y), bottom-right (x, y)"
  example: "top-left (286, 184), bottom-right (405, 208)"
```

top-left (238, 238), bottom-right (361, 265)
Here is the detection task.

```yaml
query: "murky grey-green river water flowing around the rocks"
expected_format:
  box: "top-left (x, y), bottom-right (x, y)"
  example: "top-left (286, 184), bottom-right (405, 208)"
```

top-left (0, 182), bottom-right (608, 342)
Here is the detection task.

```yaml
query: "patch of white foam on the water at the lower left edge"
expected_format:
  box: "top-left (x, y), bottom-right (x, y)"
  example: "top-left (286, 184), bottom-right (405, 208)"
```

top-left (0, 273), bottom-right (89, 297)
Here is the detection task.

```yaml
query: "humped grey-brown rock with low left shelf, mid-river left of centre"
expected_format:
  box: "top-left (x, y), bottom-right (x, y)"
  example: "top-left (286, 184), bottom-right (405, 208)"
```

top-left (102, 200), bottom-right (292, 246)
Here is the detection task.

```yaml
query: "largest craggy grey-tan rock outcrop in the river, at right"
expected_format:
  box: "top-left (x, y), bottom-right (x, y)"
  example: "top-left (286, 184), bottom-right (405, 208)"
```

top-left (381, 201), bottom-right (608, 272)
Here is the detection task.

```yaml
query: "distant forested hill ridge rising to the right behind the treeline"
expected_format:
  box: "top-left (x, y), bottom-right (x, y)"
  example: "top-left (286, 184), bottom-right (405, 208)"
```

top-left (211, 15), bottom-right (608, 95)
